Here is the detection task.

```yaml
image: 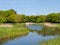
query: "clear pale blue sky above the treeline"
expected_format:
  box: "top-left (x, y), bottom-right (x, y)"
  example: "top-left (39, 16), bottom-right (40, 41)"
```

top-left (0, 0), bottom-right (60, 15)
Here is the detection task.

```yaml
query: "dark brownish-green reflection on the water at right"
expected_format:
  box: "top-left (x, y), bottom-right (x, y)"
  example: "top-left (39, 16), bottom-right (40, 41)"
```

top-left (30, 27), bottom-right (60, 36)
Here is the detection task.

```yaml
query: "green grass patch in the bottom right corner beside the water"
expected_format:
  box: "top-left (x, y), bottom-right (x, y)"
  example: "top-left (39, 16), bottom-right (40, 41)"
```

top-left (40, 38), bottom-right (60, 45)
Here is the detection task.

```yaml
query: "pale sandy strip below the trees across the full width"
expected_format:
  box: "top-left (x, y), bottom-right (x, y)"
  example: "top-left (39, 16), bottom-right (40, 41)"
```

top-left (0, 22), bottom-right (60, 27)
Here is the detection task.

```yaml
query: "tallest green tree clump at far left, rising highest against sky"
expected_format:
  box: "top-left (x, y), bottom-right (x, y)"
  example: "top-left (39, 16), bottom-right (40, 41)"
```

top-left (0, 9), bottom-right (16, 22)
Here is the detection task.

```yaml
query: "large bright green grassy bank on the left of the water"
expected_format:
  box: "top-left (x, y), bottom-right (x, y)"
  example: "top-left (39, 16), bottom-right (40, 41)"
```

top-left (0, 24), bottom-right (29, 43)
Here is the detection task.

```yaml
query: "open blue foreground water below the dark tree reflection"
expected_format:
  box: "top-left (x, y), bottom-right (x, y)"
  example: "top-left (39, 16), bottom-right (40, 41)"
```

top-left (2, 32), bottom-right (56, 45)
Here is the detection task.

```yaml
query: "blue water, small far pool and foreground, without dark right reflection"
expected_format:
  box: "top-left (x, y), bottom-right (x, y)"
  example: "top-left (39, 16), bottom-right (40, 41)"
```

top-left (1, 25), bottom-right (57, 45)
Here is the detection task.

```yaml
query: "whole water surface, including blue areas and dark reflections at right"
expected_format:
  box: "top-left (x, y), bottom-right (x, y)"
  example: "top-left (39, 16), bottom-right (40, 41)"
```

top-left (1, 25), bottom-right (60, 45)
